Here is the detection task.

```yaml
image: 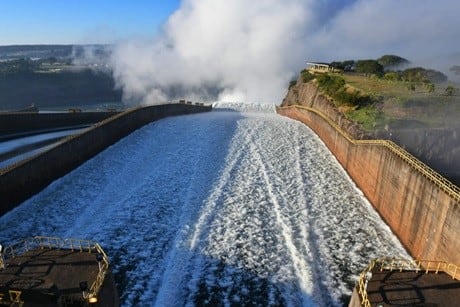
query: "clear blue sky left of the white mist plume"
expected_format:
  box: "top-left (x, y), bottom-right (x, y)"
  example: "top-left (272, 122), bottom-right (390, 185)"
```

top-left (0, 0), bottom-right (180, 45)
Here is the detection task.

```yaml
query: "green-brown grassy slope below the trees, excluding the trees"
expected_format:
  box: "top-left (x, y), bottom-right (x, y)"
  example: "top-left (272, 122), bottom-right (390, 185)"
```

top-left (302, 71), bottom-right (460, 132)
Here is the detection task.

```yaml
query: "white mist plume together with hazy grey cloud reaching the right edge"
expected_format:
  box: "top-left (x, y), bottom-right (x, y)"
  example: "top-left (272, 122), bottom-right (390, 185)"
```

top-left (111, 0), bottom-right (460, 104)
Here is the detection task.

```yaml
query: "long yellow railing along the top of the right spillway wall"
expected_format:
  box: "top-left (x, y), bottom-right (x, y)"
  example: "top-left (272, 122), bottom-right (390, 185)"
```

top-left (280, 105), bottom-right (460, 203)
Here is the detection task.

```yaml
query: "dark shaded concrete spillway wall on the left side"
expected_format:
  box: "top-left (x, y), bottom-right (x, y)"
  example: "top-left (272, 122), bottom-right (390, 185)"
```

top-left (0, 104), bottom-right (211, 216)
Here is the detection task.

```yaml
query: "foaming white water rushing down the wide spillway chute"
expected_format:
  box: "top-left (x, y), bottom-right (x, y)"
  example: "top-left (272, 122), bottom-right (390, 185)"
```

top-left (0, 105), bottom-right (408, 306)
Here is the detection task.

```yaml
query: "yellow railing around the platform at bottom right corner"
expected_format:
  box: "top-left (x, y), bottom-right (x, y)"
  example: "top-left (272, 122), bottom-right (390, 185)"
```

top-left (356, 258), bottom-right (460, 307)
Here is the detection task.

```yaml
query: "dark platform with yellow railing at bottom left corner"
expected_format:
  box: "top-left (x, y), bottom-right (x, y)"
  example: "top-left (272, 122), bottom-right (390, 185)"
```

top-left (0, 236), bottom-right (114, 306)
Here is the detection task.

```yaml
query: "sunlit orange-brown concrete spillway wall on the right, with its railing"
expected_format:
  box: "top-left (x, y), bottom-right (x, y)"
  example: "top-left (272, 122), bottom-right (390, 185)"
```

top-left (278, 106), bottom-right (460, 264)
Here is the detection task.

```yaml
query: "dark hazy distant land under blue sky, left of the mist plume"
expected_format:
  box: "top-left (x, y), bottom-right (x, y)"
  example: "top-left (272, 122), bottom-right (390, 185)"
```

top-left (0, 45), bottom-right (122, 111)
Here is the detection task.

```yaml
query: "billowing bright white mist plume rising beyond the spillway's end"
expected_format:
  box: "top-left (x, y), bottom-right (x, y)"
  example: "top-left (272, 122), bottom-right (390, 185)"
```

top-left (109, 0), bottom-right (312, 103)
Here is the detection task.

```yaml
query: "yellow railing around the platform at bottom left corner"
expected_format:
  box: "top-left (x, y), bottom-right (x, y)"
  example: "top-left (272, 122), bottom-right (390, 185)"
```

top-left (0, 236), bottom-right (109, 300)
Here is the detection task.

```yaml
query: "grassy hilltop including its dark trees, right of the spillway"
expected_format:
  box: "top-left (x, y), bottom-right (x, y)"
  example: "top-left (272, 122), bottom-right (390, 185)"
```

top-left (291, 55), bottom-right (460, 132)
